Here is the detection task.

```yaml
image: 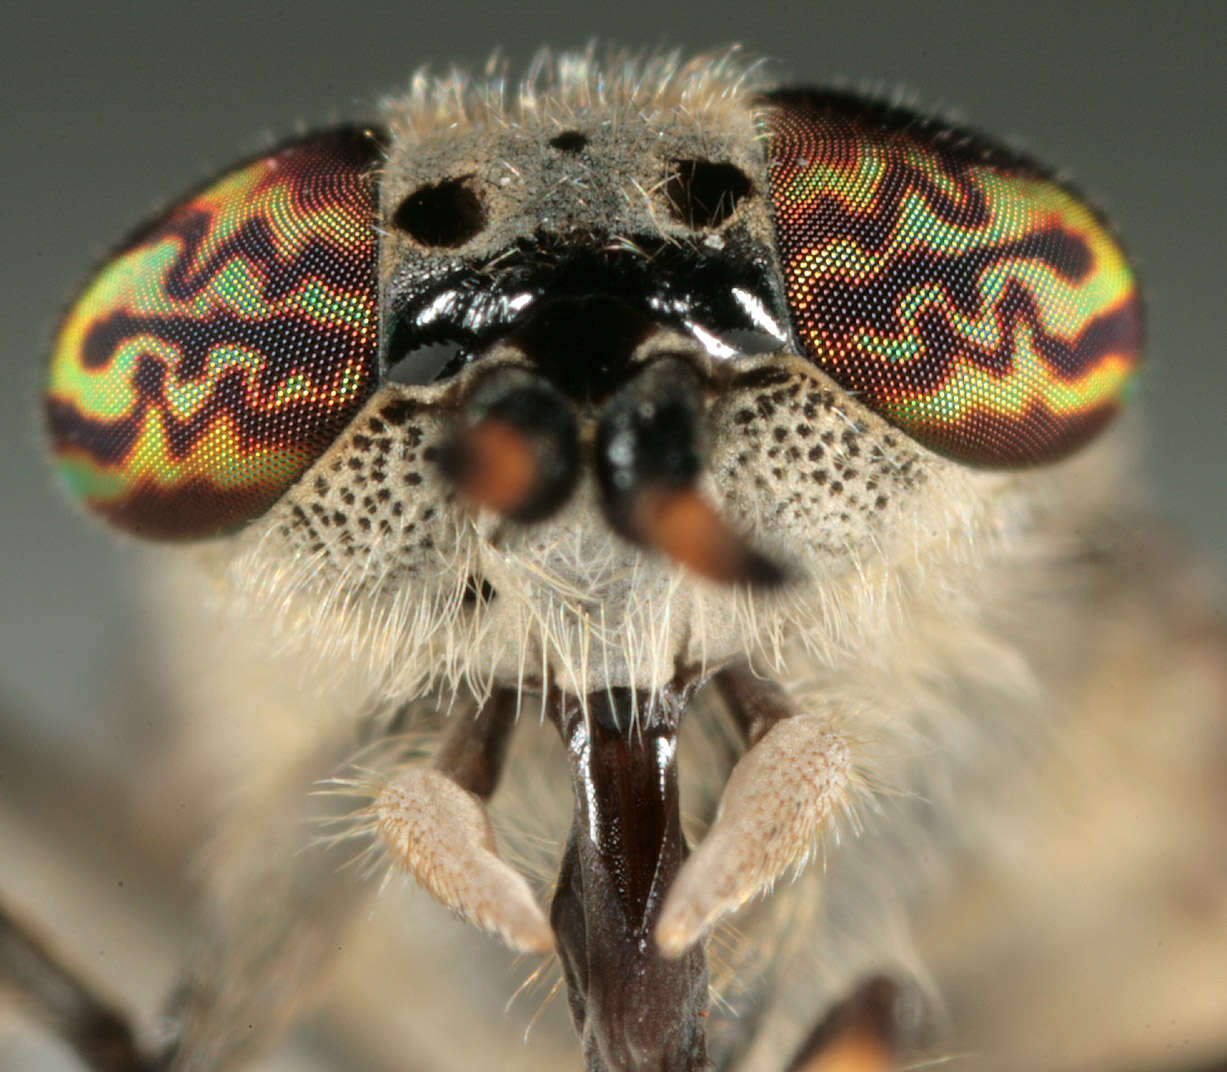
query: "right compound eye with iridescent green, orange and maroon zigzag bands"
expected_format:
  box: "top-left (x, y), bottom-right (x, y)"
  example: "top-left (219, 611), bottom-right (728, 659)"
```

top-left (761, 91), bottom-right (1142, 466)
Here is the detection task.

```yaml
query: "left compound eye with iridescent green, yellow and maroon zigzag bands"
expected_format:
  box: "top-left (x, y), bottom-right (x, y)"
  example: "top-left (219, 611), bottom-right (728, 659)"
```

top-left (45, 128), bottom-right (380, 540)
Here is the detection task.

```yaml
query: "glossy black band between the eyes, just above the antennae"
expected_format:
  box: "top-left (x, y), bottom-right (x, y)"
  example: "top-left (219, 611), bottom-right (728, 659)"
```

top-left (385, 235), bottom-right (784, 405)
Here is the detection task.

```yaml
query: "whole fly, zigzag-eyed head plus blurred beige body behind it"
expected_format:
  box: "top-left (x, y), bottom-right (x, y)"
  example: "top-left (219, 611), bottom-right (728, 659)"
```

top-left (11, 53), bottom-right (1227, 1072)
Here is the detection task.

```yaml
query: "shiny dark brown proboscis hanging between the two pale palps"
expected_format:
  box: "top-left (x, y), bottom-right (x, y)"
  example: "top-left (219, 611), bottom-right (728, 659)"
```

top-left (550, 682), bottom-right (709, 1072)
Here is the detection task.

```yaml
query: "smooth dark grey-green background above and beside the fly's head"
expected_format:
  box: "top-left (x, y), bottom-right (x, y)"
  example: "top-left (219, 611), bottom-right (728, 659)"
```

top-left (0, 0), bottom-right (1227, 747)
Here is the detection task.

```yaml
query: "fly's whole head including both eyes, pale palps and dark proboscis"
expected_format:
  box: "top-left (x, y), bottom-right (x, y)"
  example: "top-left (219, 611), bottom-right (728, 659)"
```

top-left (31, 50), bottom-right (1207, 1070)
